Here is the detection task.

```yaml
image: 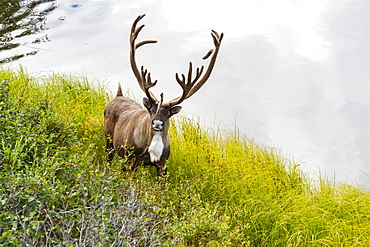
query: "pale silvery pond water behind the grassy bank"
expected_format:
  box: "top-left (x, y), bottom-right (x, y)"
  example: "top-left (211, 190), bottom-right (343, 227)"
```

top-left (0, 0), bottom-right (370, 186)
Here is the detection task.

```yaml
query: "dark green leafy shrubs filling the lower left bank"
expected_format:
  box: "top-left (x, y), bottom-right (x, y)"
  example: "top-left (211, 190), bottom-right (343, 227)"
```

top-left (0, 69), bottom-right (178, 246)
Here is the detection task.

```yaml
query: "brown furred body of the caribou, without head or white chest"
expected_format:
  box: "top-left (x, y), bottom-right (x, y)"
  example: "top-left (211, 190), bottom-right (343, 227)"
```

top-left (104, 89), bottom-right (170, 174)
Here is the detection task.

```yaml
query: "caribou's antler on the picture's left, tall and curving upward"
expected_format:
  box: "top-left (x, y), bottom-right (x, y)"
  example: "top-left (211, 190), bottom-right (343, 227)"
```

top-left (130, 14), bottom-right (158, 102)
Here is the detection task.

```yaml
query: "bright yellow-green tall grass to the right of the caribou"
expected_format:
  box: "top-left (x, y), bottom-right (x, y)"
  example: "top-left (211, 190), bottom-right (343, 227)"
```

top-left (169, 119), bottom-right (370, 246)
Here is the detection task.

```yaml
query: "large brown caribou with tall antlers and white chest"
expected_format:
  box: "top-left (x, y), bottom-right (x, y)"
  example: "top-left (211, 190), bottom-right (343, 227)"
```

top-left (104, 15), bottom-right (223, 176)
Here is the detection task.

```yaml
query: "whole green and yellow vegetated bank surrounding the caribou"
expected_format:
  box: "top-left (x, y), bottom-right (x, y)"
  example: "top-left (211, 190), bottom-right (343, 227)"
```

top-left (0, 68), bottom-right (370, 246)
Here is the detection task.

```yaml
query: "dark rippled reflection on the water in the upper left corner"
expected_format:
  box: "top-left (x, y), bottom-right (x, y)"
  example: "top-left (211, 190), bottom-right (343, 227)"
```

top-left (0, 0), bottom-right (56, 63)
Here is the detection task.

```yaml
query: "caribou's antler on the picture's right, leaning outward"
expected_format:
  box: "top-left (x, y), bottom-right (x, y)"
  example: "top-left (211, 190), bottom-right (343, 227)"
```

top-left (166, 30), bottom-right (224, 106)
